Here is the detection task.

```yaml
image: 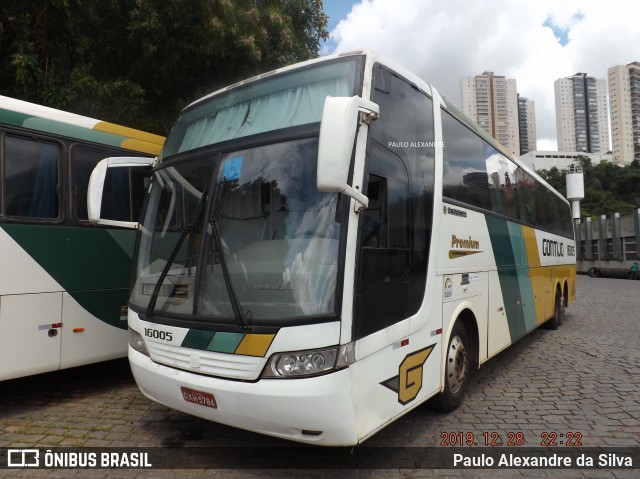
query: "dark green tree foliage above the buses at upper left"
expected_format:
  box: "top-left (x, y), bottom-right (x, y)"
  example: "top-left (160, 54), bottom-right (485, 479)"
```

top-left (0, 0), bottom-right (328, 134)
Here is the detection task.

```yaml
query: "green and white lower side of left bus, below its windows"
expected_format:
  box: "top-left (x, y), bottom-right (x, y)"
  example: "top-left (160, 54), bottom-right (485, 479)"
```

top-left (0, 224), bottom-right (135, 379)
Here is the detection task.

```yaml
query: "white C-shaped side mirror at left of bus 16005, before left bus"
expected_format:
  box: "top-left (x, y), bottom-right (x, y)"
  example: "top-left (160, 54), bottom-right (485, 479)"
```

top-left (87, 157), bottom-right (156, 228)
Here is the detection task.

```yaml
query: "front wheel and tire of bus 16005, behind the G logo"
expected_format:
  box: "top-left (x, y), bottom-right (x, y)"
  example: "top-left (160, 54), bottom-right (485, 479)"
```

top-left (431, 321), bottom-right (472, 412)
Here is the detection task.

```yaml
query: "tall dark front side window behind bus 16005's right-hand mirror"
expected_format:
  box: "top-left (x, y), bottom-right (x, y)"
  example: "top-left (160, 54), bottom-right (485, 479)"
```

top-left (353, 65), bottom-right (435, 339)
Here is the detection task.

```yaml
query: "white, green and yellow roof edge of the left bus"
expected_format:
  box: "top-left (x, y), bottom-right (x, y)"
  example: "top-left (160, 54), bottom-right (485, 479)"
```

top-left (0, 95), bottom-right (164, 155)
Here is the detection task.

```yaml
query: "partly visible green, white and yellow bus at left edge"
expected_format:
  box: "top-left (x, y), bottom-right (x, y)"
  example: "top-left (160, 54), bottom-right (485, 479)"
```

top-left (0, 96), bottom-right (164, 380)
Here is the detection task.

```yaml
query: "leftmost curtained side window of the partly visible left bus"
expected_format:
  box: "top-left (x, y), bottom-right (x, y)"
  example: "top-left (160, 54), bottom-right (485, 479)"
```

top-left (4, 135), bottom-right (61, 219)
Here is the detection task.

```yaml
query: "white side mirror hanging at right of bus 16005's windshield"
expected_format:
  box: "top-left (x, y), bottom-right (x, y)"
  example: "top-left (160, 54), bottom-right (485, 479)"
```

top-left (317, 96), bottom-right (380, 207)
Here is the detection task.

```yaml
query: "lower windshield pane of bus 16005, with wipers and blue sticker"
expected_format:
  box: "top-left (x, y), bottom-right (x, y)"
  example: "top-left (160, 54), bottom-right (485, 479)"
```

top-left (131, 138), bottom-right (341, 324)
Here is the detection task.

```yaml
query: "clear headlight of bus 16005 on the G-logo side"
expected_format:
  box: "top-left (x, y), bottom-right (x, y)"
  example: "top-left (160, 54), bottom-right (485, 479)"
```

top-left (262, 343), bottom-right (354, 378)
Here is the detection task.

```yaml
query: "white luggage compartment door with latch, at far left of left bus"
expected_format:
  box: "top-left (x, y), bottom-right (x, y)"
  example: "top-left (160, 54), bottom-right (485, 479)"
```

top-left (0, 293), bottom-right (62, 380)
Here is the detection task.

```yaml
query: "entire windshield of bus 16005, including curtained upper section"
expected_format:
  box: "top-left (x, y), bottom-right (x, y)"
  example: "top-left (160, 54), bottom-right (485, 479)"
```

top-left (131, 57), bottom-right (362, 329)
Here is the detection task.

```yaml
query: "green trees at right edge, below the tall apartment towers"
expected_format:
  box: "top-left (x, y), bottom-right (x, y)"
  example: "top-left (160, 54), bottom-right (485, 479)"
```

top-left (537, 156), bottom-right (640, 218)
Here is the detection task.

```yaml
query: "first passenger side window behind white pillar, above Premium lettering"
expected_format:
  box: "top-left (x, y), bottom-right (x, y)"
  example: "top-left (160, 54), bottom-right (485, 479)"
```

top-left (442, 110), bottom-right (492, 210)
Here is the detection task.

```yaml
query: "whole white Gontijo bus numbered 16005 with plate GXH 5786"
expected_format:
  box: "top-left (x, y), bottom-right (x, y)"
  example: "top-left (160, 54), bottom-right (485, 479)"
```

top-left (92, 52), bottom-right (576, 445)
